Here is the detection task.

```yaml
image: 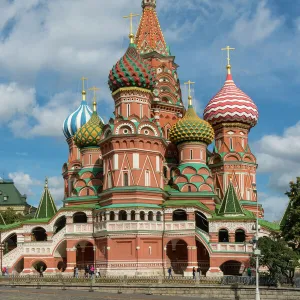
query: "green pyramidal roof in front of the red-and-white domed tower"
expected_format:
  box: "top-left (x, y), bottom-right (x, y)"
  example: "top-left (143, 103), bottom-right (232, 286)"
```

top-left (218, 182), bottom-right (244, 215)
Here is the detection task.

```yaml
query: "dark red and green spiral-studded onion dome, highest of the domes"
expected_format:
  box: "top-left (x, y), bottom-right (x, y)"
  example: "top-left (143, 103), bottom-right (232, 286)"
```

top-left (108, 43), bottom-right (154, 92)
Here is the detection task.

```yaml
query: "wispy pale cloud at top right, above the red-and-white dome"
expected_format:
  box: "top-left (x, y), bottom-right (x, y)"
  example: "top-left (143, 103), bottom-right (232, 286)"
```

top-left (231, 0), bottom-right (284, 46)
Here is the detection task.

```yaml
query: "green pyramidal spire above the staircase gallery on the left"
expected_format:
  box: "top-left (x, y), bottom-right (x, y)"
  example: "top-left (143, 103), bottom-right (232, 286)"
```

top-left (34, 178), bottom-right (57, 219)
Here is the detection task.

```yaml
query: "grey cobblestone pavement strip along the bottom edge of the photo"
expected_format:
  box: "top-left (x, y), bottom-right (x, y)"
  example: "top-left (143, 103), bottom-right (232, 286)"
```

top-left (0, 287), bottom-right (218, 300)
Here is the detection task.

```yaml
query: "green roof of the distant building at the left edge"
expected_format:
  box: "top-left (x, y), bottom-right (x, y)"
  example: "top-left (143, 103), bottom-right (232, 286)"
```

top-left (0, 178), bottom-right (28, 206)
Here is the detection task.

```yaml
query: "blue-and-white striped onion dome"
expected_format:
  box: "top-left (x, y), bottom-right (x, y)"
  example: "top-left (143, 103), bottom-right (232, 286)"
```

top-left (63, 100), bottom-right (93, 139)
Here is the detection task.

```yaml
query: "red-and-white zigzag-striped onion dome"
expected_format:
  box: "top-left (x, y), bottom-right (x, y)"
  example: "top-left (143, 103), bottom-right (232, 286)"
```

top-left (203, 70), bottom-right (258, 127)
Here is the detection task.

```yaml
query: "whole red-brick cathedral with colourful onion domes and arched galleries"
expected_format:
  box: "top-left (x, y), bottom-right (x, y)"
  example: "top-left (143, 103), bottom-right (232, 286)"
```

top-left (0, 0), bottom-right (277, 276)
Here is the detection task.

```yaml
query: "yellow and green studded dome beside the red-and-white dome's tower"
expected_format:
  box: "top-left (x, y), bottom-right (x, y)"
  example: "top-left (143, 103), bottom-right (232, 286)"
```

top-left (170, 100), bottom-right (215, 145)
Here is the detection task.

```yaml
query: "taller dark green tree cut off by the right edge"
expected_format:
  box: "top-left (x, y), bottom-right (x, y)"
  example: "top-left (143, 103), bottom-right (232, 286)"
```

top-left (281, 177), bottom-right (300, 252)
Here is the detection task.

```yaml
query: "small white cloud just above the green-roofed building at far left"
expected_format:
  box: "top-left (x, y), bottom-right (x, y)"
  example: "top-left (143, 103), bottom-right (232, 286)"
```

top-left (8, 172), bottom-right (41, 196)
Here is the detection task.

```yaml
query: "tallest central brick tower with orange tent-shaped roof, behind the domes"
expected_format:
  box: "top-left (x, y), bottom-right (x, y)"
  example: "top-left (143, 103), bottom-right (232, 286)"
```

top-left (135, 0), bottom-right (184, 137)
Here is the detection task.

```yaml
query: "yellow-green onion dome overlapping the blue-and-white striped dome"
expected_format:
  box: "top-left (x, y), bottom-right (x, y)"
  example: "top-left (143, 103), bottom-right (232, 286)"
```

top-left (74, 101), bottom-right (104, 148)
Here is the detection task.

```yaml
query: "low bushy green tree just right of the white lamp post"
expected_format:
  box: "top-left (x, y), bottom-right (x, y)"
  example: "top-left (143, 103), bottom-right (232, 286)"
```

top-left (253, 234), bottom-right (300, 283)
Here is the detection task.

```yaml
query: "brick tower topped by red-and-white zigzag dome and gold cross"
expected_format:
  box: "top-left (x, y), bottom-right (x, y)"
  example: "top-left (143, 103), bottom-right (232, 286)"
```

top-left (204, 46), bottom-right (258, 210)
